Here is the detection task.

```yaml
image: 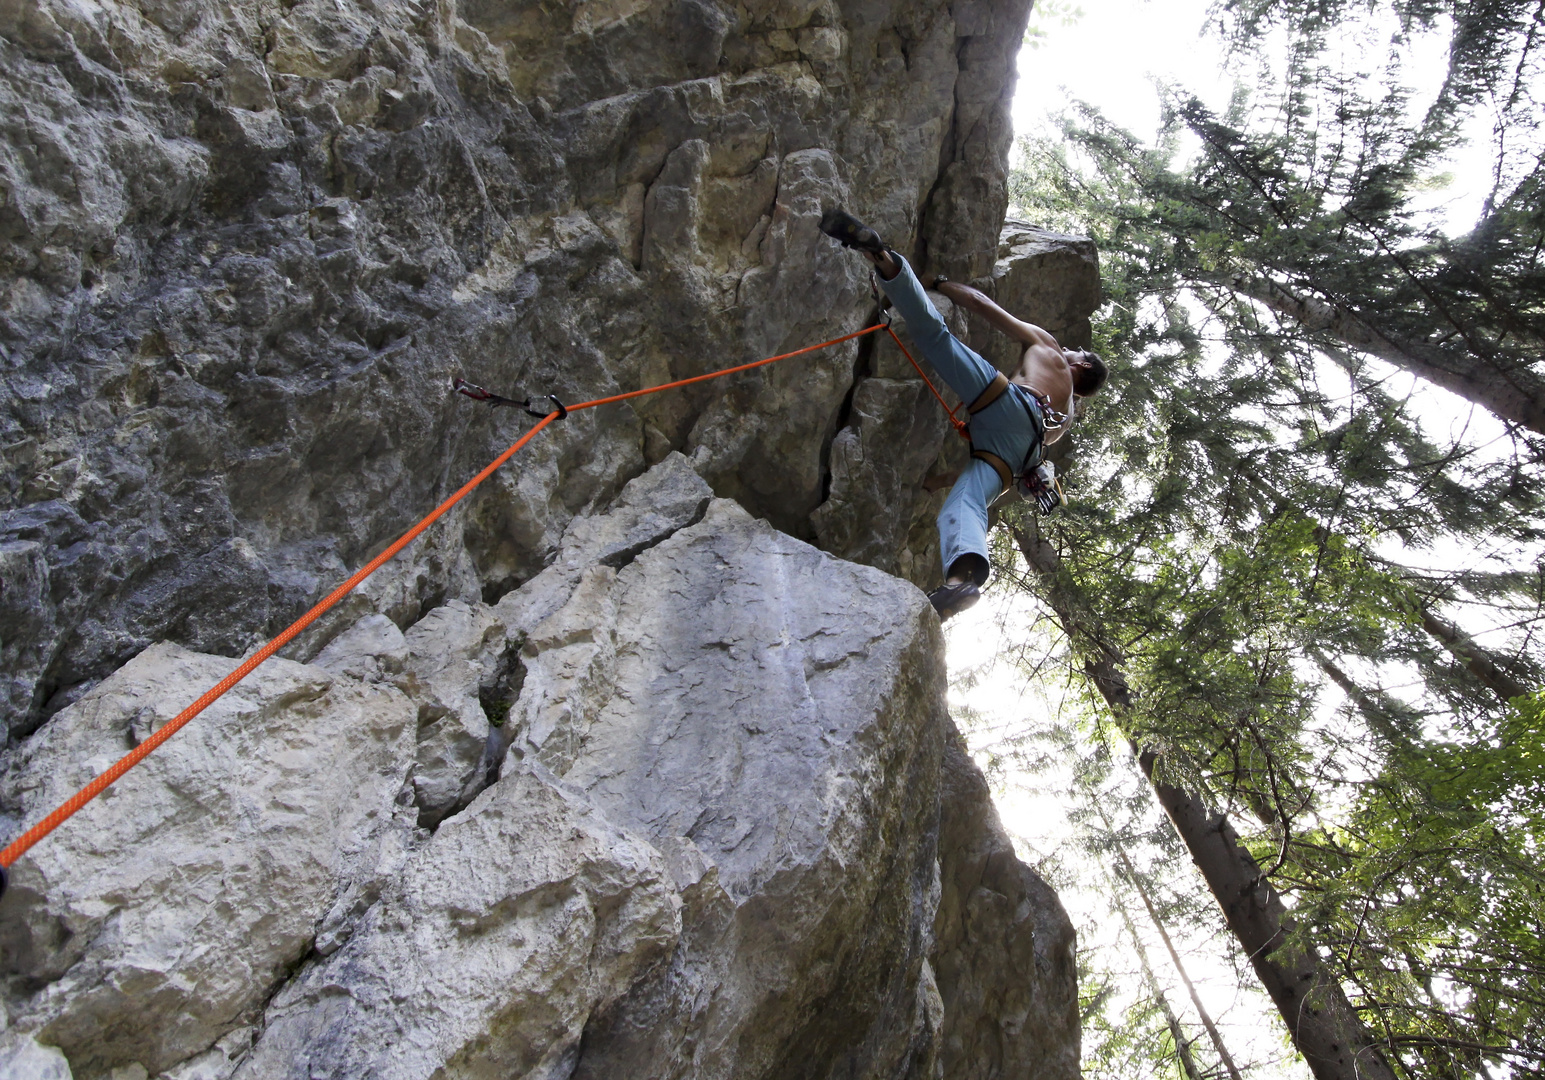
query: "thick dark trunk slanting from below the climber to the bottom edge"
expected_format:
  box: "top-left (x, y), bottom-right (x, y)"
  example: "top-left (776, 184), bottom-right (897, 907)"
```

top-left (1014, 525), bottom-right (1395, 1080)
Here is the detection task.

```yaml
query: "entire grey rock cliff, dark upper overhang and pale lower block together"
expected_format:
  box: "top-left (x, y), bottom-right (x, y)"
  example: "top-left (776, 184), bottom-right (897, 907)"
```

top-left (0, 0), bottom-right (1098, 1080)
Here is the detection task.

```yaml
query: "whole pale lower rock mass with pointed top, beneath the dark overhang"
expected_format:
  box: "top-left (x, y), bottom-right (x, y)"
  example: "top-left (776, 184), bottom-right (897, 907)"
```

top-left (0, 454), bottom-right (1078, 1080)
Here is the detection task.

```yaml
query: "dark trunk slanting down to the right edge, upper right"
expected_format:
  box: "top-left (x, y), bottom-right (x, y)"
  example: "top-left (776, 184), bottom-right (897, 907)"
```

top-left (1225, 275), bottom-right (1545, 434)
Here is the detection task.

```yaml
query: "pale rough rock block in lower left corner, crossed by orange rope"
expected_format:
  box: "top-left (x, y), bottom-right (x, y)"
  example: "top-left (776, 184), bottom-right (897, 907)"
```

top-left (0, 644), bottom-right (416, 1075)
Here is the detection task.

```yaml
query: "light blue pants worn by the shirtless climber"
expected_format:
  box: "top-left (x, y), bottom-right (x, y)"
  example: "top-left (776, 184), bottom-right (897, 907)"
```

top-left (879, 253), bottom-right (1041, 586)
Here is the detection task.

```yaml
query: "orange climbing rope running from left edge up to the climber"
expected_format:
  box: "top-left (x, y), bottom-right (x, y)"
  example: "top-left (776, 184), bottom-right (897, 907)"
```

top-left (0, 323), bottom-right (966, 868)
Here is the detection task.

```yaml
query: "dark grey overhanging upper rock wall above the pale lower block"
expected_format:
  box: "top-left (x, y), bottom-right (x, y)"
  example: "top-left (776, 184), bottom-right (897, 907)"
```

top-left (0, 0), bottom-right (1100, 737)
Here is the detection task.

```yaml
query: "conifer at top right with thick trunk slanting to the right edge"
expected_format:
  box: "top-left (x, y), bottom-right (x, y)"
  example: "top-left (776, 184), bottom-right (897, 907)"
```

top-left (1013, 0), bottom-right (1545, 433)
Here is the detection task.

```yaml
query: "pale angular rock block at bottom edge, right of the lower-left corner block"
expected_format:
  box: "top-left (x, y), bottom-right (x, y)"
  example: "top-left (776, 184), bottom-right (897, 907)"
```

top-left (235, 763), bottom-right (681, 1080)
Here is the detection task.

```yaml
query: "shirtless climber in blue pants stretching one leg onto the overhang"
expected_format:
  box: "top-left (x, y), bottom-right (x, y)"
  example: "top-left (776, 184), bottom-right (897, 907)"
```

top-left (820, 210), bottom-right (1106, 620)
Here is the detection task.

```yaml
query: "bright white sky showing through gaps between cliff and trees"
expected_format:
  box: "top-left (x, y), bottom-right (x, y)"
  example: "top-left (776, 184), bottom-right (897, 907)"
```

top-left (947, 0), bottom-right (1492, 1080)
